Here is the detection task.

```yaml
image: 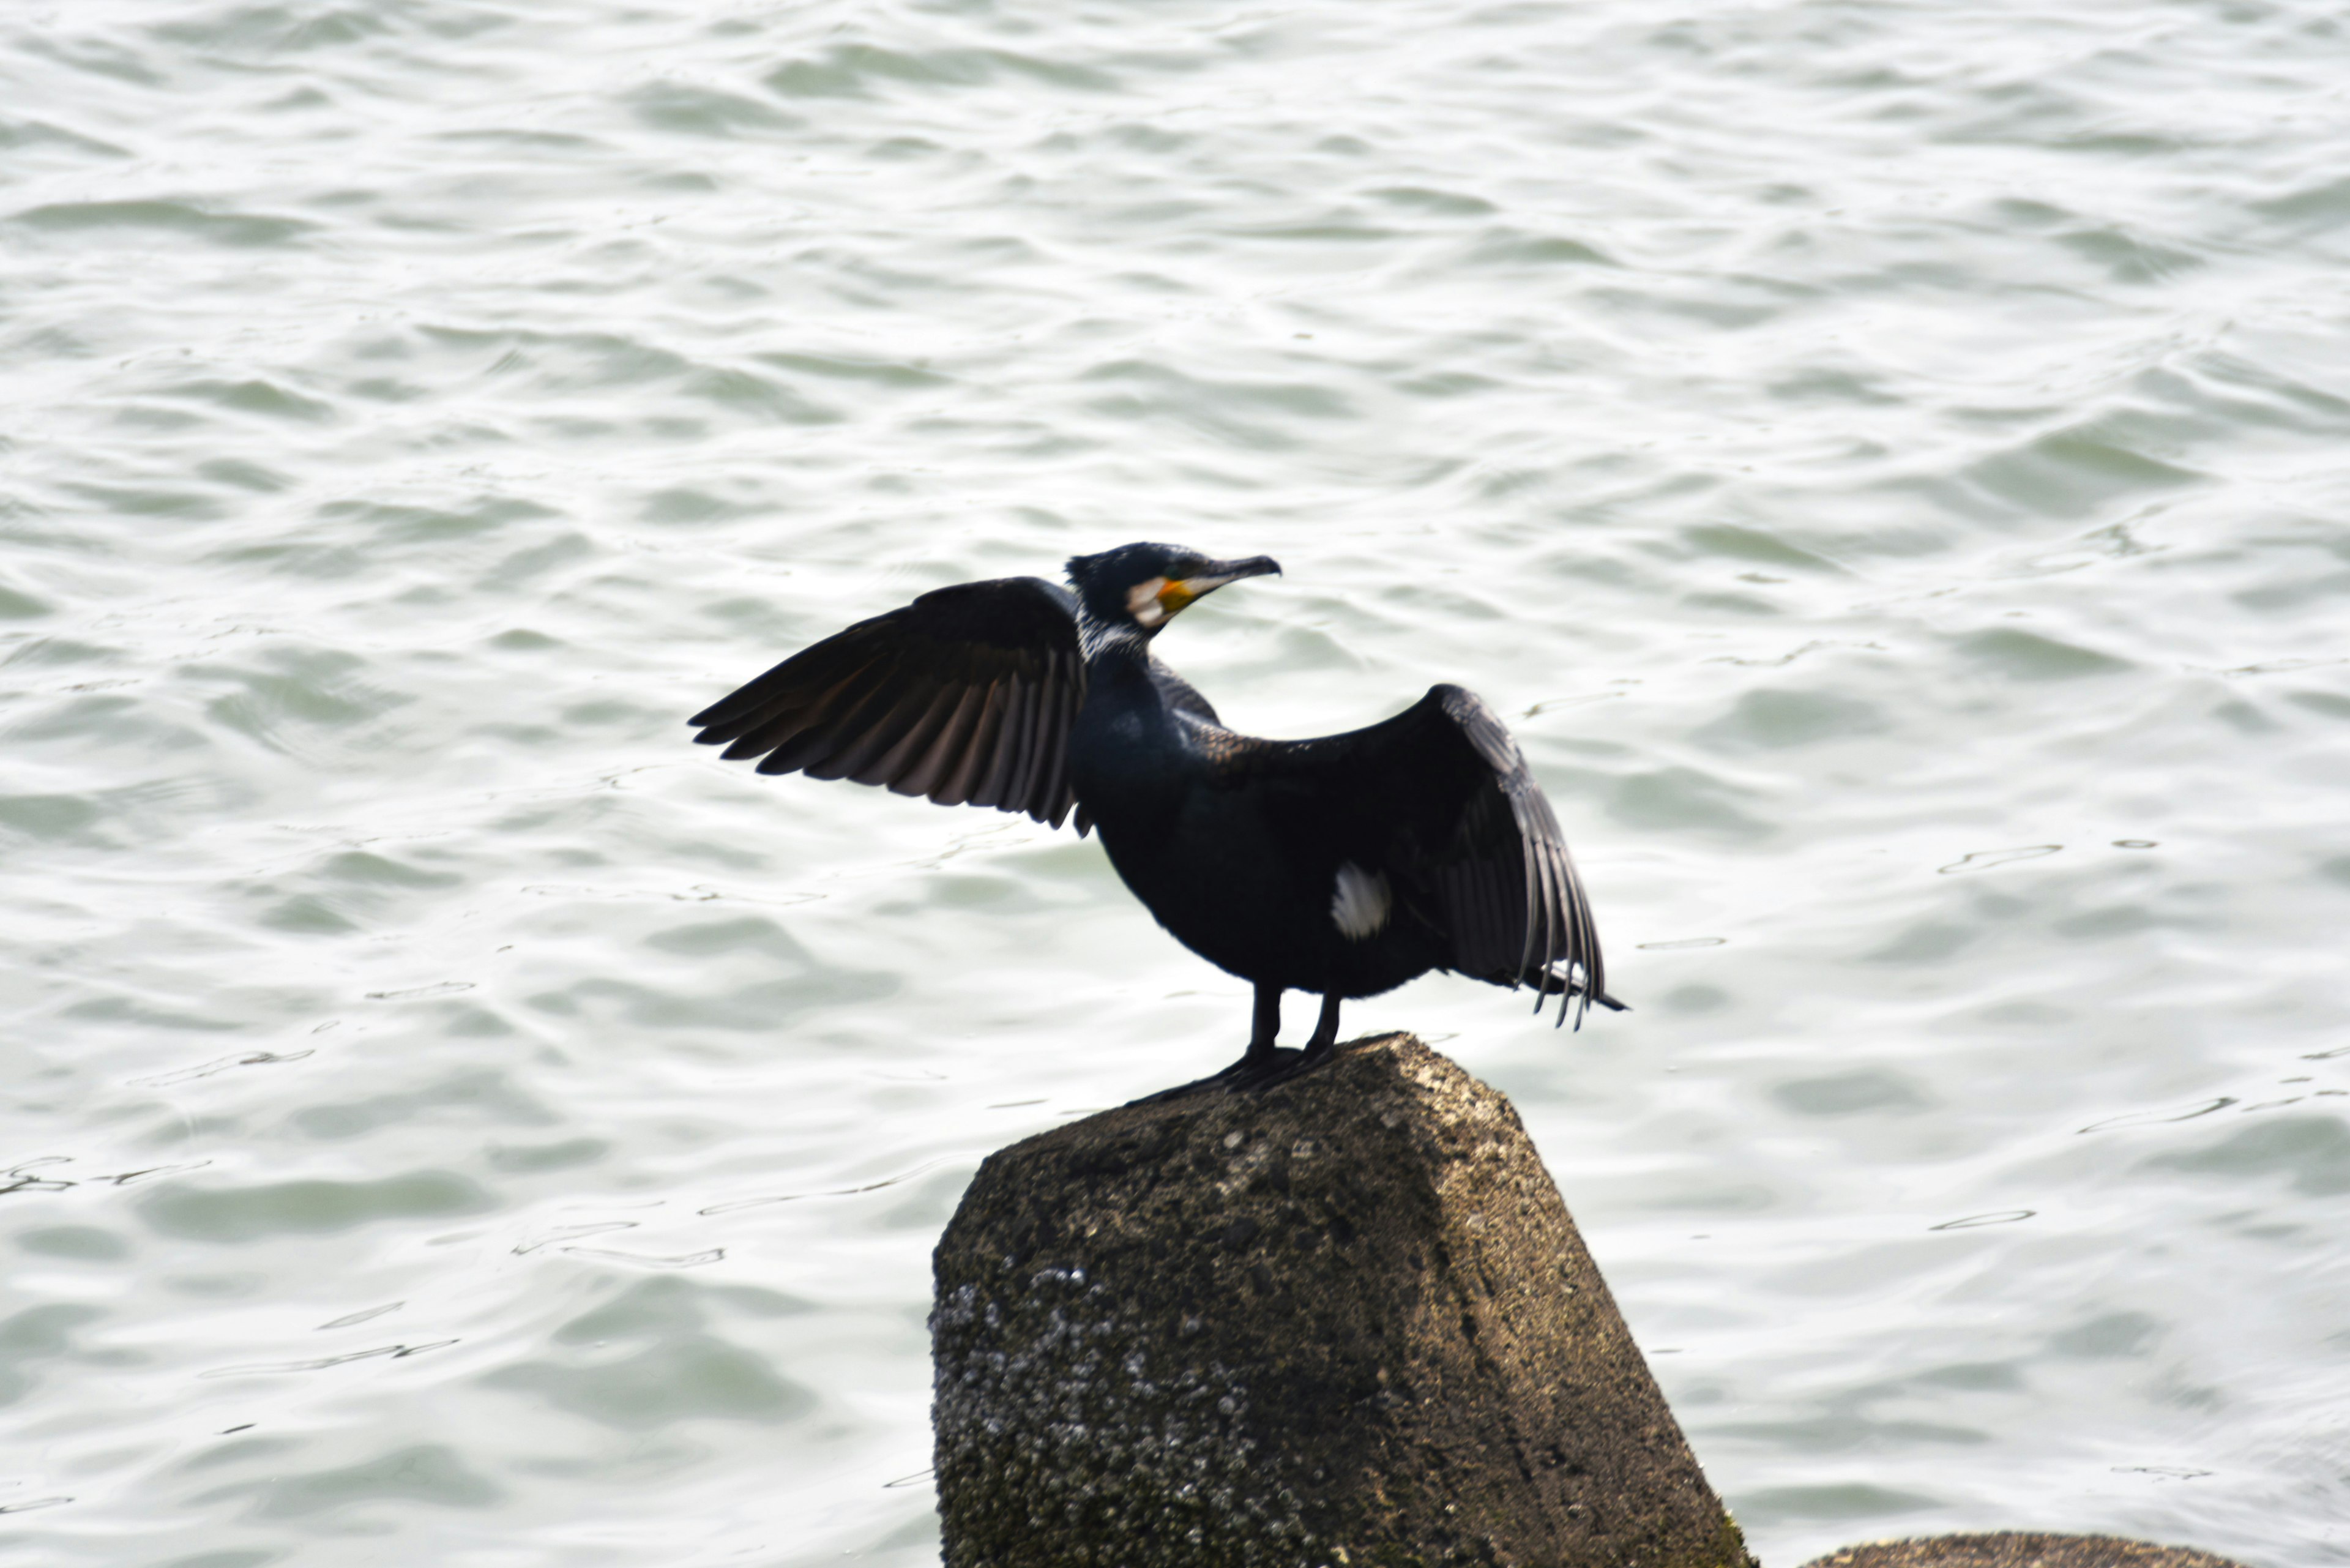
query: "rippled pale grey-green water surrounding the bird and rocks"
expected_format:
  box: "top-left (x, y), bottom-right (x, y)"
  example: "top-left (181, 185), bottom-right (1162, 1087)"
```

top-left (0, 0), bottom-right (2350, 1568)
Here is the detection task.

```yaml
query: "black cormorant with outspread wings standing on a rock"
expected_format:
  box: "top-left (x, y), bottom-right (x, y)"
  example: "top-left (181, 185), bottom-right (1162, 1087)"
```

top-left (688, 545), bottom-right (1624, 1086)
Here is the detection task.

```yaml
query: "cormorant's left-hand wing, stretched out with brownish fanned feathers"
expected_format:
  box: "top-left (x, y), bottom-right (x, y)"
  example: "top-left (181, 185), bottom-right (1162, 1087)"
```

top-left (688, 578), bottom-right (1086, 827)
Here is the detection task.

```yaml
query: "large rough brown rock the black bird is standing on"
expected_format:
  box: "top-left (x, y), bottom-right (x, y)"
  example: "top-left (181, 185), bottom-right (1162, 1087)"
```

top-left (931, 1034), bottom-right (1753, 1568)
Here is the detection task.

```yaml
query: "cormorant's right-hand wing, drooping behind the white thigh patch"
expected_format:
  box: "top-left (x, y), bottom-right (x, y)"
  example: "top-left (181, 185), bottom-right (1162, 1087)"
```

top-left (1241, 687), bottom-right (1624, 1025)
